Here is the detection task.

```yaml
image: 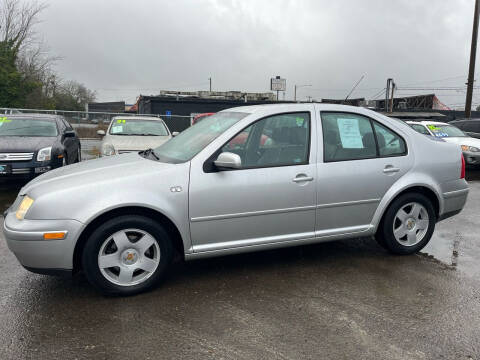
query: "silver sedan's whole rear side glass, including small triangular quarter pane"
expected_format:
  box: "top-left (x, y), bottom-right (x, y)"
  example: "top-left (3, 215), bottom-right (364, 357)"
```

top-left (321, 112), bottom-right (406, 162)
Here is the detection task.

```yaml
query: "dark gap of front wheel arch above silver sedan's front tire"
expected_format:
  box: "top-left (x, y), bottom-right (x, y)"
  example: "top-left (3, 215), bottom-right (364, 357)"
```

top-left (73, 206), bottom-right (185, 272)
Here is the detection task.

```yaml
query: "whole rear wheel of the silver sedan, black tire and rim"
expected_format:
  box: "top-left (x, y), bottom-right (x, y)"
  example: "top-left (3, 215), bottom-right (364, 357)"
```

top-left (375, 193), bottom-right (436, 255)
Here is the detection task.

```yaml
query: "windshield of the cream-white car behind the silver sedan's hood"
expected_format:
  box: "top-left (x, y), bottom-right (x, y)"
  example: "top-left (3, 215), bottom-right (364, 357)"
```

top-left (110, 118), bottom-right (168, 136)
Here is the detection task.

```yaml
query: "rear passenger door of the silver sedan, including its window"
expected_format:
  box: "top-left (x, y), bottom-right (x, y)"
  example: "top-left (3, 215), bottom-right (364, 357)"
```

top-left (315, 111), bottom-right (411, 236)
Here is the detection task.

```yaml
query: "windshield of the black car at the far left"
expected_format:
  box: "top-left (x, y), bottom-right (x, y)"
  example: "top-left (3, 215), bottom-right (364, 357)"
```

top-left (0, 116), bottom-right (58, 137)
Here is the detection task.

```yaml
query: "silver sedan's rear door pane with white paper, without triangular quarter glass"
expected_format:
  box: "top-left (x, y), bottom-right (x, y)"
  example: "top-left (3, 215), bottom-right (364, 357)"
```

top-left (321, 113), bottom-right (377, 162)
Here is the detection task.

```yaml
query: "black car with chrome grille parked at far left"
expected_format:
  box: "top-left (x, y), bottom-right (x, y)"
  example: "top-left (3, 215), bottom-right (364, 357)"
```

top-left (0, 114), bottom-right (81, 177)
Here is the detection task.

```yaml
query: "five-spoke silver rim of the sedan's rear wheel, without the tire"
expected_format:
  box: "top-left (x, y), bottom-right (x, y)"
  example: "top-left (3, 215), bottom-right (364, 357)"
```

top-left (393, 202), bottom-right (430, 246)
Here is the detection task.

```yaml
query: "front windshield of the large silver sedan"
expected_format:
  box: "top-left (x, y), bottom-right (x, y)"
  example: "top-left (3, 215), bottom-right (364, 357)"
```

top-left (154, 112), bottom-right (248, 164)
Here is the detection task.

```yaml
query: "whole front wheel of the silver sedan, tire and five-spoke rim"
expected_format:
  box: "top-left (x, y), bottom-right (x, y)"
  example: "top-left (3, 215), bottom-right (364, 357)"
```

top-left (82, 215), bottom-right (173, 295)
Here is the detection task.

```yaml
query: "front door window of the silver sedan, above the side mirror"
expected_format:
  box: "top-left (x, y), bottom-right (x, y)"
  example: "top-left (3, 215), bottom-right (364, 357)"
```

top-left (222, 113), bottom-right (310, 168)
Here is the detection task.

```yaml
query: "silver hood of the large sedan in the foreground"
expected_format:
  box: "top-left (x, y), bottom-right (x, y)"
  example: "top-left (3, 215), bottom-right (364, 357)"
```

top-left (20, 153), bottom-right (174, 198)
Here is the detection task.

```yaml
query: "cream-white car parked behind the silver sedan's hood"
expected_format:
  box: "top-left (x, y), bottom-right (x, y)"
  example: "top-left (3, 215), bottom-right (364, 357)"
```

top-left (97, 116), bottom-right (172, 156)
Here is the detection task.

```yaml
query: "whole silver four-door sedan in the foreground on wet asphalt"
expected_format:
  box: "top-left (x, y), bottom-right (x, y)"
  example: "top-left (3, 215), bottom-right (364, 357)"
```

top-left (4, 103), bottom-right (468, 295)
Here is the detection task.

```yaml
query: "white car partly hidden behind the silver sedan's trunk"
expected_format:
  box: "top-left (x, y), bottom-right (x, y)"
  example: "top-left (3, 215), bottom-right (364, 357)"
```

top-left (407, 121), bottom-right (480, 166)
